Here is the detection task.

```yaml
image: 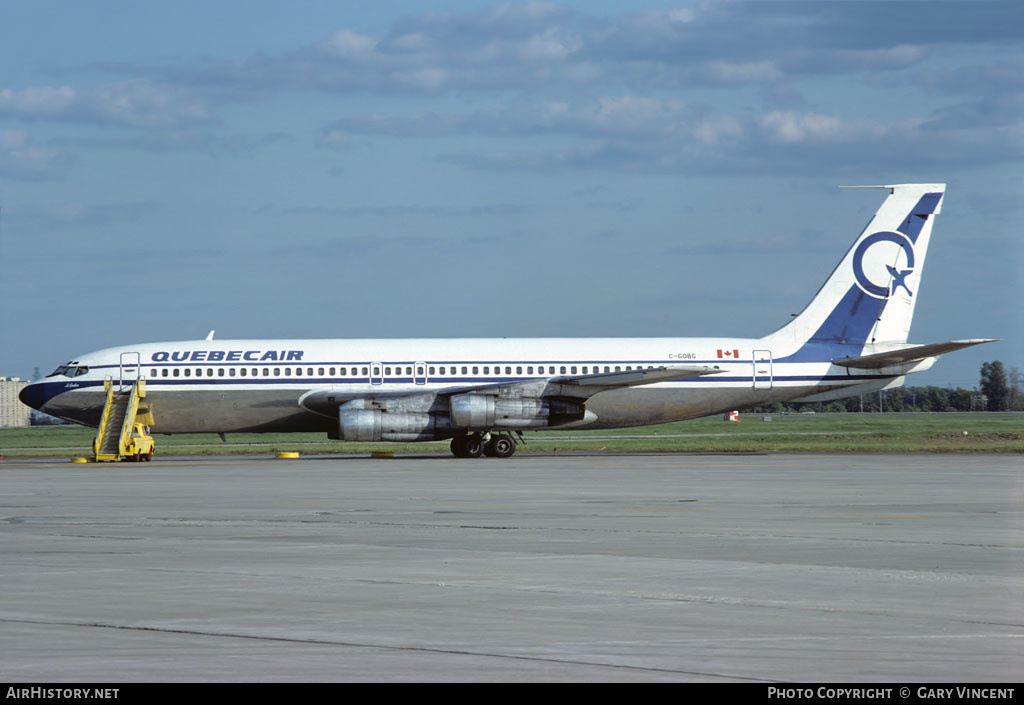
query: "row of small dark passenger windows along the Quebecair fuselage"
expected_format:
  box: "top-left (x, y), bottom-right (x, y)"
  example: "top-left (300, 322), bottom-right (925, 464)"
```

top-left (152, 365), bottom-right (653, 377)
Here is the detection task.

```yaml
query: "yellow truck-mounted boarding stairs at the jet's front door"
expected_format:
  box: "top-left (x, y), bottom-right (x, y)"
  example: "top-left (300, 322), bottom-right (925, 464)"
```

top-left (92, 379), bottom-right (153, 462)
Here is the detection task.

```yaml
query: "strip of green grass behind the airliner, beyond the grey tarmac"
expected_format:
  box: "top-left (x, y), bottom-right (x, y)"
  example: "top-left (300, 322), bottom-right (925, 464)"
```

top-left (0, 413), bottom-right (1024, 457)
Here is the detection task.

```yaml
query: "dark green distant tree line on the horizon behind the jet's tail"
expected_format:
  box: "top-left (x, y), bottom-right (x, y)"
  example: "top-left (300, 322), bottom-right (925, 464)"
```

top-left (752, 360), bottom-right (1024, 413)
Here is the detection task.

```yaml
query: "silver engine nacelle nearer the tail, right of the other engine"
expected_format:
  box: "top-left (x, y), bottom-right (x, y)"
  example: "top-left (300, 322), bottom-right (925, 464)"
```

top-left (450, 393), bottom-right (586, 430)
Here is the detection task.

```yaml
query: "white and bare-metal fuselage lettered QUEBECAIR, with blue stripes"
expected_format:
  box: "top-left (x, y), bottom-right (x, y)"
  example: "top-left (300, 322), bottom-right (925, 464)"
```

top-left (28, 338), bottom-right (896, 433)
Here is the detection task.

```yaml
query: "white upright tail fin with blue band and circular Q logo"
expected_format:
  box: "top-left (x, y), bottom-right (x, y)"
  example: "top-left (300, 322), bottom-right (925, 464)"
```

top-left (768, 183), bottom-right (945, 354)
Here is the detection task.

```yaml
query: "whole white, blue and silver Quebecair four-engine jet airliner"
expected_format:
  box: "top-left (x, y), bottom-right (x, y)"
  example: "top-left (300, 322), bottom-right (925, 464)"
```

top-left (20, 183), bottom-right (989, 457)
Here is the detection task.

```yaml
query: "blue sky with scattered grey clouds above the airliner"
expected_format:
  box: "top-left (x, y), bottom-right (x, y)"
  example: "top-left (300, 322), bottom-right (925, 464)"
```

top-left (0, 0), bottom-right (1024, 386)
